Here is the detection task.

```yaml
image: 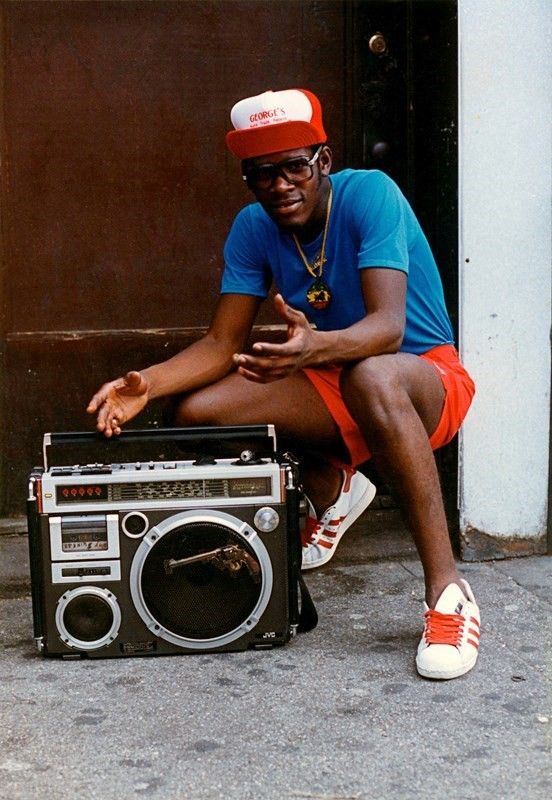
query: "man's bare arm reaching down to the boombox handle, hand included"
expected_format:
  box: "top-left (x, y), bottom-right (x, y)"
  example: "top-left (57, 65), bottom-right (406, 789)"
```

top-left (86, 294), bottom-right (261, 437)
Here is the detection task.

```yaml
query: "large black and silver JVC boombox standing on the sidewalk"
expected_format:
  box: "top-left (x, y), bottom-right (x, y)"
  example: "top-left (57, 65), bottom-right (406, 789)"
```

top-left (28, 426), bottom-right (316, 658)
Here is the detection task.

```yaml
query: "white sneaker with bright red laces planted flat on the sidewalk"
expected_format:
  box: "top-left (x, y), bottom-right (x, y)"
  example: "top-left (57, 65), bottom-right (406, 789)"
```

top-left (416, 580), bottom-right (481, 680)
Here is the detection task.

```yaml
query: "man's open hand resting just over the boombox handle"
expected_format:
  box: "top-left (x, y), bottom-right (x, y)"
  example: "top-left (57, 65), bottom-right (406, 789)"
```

top-left (86, 371), bottom-right (149, 438)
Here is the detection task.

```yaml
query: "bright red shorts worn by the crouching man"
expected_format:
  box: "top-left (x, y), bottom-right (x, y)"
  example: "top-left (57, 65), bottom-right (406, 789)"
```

top-left (303, 344), bottom-right (475, 466)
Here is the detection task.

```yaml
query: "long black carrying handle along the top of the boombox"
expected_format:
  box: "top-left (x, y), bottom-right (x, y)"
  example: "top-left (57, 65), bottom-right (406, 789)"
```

top-left (42, 425), bottom-right (276, 472)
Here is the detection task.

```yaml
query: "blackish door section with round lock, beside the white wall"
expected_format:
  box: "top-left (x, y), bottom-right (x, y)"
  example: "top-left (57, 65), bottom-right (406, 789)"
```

top-left (351, 0), bottom-right (458, 327)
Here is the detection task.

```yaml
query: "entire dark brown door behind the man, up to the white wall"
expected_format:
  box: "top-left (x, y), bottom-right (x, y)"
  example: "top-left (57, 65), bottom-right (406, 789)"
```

top-left (0, 0), bottom-right (457, 514)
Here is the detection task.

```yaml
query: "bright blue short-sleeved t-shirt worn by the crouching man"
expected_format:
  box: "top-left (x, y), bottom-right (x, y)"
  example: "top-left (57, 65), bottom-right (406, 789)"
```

top-left (221, 169), bottom-right (453, 353)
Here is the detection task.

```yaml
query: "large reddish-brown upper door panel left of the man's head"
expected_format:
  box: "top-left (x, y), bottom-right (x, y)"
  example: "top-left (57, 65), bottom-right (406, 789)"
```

top-left (4, 0), bottom-right (350, 332)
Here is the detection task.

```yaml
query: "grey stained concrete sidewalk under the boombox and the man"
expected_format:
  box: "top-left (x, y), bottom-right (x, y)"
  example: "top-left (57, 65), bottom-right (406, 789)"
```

top-left (0, 515), bottom-right (552, 800)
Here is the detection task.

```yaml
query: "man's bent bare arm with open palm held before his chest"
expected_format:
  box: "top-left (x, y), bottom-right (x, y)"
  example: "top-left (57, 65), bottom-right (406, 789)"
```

top-left (234, 267), bottom-right (406, 383)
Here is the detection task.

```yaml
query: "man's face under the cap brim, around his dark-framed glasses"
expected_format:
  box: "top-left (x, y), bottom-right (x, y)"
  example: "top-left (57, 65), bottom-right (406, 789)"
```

top-left (246, 146), bottom-right (332, 231)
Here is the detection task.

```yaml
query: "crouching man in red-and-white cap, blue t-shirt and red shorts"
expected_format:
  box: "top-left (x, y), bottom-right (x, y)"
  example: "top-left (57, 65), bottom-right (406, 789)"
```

top-left (88, 89), bottom-right (479, 679)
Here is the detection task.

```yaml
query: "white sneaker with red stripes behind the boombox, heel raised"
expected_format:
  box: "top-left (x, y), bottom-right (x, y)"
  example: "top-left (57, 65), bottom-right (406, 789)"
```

top-left (302, 469), bottom-right (376, 569)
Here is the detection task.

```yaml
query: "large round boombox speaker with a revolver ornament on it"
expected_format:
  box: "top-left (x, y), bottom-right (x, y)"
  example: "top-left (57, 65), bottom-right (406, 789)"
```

top-left (132, 511), bottom-right (272, 649)
